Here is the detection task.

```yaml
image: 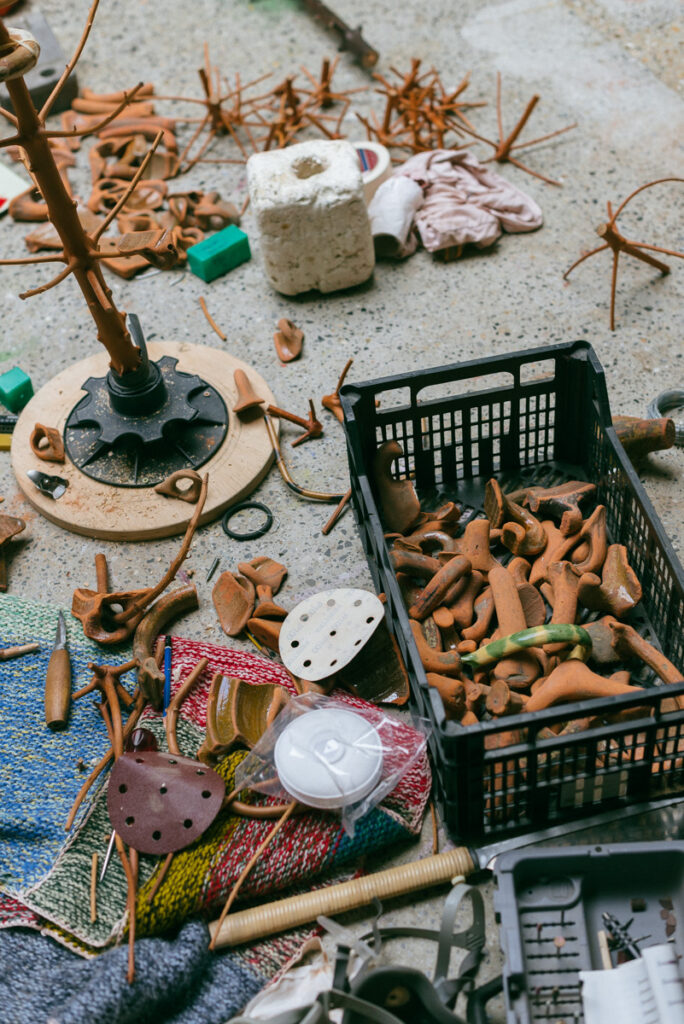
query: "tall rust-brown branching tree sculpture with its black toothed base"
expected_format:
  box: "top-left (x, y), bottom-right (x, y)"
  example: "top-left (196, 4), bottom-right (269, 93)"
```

top-left (0, 0), bottom-right (227, 486)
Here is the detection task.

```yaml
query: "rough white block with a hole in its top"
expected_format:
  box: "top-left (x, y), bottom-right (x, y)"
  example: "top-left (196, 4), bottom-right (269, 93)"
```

top-left (247, 140), bottom-right (375, 295)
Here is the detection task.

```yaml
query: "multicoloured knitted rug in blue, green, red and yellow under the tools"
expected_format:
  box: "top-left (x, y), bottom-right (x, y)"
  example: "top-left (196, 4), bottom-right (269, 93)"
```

top-left (0, 598), bottom-right (430, 955)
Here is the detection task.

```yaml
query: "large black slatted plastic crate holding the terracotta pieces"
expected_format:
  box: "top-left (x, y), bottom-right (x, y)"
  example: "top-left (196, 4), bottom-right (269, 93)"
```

top-left (341, 341), bottom-right (684, 842)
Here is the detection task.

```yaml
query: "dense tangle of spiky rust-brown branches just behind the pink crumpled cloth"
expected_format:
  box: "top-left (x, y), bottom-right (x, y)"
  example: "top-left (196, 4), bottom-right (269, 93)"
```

top-left (356, 57), bottom-right (486, 153)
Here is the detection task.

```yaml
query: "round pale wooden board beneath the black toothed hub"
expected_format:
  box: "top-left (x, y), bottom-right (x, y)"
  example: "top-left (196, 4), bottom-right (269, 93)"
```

top-left (11, 342), bottom-right (275, 541)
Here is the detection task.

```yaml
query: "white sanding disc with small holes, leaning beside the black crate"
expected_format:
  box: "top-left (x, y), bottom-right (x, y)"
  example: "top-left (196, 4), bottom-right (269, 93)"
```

top-left (279, 589), bottom-right (385, 682)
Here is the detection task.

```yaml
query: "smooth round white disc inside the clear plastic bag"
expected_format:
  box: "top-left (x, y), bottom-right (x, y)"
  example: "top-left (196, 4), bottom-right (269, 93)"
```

top-left (273, 708), bottom-right (382, 810)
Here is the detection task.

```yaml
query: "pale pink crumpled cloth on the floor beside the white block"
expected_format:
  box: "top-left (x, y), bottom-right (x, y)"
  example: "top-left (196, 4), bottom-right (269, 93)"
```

top-left (395, 150), bottom-right (543, 252)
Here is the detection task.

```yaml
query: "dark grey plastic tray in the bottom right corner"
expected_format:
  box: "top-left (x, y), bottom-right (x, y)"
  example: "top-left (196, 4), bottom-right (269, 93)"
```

top-left (494, 843), bottom-right (684, 1024)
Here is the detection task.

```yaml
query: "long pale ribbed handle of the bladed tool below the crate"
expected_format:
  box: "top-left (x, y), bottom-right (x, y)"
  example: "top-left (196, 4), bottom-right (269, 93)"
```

top-left (209, 847), bottom-right (479, 948)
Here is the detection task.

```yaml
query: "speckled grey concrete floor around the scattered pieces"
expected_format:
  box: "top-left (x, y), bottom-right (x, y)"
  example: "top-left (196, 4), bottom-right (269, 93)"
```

top-left (0, 0), bottom-right (684, 1021)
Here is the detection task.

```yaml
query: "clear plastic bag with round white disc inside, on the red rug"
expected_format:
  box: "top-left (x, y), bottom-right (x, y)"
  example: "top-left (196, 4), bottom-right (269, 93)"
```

top-left (236, 693), bottom-right (428, 835)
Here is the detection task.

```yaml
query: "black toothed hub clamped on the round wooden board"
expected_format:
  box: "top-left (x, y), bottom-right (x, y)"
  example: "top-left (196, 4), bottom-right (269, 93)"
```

top-left (65, 316), bottom-right (228, 487)
